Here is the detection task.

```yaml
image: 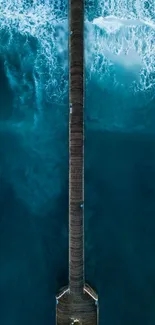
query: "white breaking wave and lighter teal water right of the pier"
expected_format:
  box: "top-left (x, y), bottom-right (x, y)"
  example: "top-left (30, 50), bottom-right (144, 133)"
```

top-left (85, 0), bottom-right (155, 130)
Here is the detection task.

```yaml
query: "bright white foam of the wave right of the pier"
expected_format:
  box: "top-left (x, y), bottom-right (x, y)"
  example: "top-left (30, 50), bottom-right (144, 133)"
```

top-left (85, 0), bottom-right (155, 99)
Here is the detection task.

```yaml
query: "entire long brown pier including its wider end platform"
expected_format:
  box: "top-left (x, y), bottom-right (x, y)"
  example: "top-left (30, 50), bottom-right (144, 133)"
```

top-left (56, 0), bottom-right (99, 325)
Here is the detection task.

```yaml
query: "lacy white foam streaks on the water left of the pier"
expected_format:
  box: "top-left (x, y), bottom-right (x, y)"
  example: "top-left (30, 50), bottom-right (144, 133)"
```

top-left (0, 0), bottom-right (68, 111)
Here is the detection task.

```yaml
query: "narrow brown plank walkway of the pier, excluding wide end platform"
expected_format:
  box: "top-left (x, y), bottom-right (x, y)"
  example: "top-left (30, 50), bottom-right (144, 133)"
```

top-left (69, 0), bottom-right (84, 293)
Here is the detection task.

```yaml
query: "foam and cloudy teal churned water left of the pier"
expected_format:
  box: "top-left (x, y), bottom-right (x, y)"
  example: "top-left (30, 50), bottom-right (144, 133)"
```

top-left (0, 0), bottom-right (68, 215)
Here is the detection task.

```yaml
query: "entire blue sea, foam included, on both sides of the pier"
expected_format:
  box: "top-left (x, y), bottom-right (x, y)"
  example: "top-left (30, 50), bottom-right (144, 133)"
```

top-left (0, 0), bottom-right (155, 325)
